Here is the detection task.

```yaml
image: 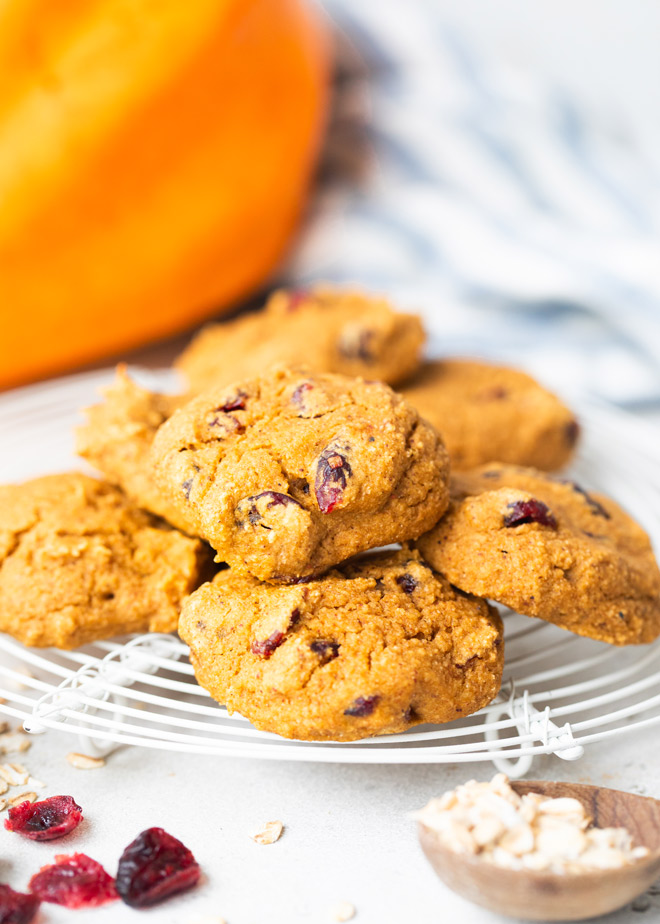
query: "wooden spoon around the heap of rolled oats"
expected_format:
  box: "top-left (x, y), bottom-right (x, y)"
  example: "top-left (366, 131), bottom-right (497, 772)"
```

top-left (419, 780), bottom-right (660, 921)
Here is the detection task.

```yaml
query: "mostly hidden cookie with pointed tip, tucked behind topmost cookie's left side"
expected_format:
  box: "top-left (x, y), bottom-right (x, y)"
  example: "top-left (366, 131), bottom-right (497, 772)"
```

top-left (76, 366), bottom-right (194, 534)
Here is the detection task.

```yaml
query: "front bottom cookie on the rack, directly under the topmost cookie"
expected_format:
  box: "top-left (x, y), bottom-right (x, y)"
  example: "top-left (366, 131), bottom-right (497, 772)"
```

top-left (179, 550), bottom-right (503, 741)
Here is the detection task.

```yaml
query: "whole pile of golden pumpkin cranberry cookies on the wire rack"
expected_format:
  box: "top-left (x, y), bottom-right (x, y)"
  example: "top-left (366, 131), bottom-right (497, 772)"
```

top-left (0, 289), bottom-right (660, 741)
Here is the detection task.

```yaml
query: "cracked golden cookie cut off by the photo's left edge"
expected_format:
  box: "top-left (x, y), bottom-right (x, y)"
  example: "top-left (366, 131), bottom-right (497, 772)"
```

top-left (0, 473), bottom-right (209, 648)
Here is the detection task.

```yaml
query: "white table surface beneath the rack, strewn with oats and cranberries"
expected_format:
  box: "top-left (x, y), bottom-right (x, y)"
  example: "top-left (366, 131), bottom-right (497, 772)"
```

top-left (0, 731), bottom-right (660, 924)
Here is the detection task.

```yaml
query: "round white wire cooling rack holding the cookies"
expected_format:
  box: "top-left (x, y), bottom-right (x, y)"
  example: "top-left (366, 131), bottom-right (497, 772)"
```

top-left (0, 370), bottom-right (660, 776)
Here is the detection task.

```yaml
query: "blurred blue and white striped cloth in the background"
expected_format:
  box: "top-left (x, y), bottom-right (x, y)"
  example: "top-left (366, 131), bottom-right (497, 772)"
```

top-left (288, 0), bottom-right (660, 409)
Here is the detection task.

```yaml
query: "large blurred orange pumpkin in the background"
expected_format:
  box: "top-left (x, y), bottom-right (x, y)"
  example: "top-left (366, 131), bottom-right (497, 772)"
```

top-left (0, 0), bottom-right (329, 386)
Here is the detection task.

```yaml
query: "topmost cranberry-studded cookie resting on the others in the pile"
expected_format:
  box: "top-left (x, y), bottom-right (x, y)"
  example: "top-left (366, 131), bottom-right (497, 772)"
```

top-left (151, 368), bottom-right (449, 581)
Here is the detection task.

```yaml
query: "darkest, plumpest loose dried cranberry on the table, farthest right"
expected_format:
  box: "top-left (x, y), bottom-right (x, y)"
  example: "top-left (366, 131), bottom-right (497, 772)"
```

top-left (117, 828), bottom-right (200, 908)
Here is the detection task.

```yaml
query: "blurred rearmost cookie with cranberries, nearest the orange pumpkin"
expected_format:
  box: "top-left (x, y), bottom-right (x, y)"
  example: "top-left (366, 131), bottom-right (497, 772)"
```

top-left (177, 287), bottom-right (425, 392)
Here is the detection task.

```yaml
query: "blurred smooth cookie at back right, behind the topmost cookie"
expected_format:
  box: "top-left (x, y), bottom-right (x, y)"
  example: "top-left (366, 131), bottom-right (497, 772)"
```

top-left (399, 359), bottom-right (579, 471)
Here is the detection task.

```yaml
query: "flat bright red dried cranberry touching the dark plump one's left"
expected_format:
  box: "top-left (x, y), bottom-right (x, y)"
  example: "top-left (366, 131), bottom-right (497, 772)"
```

top-left (28, 853), bottom-right (117, 908)
